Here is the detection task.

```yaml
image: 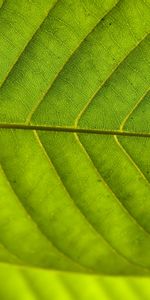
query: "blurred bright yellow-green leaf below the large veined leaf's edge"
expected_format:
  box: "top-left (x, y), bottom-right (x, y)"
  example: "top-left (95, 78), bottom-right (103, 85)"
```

top-left (0, 266), bottom-right (150, 300)
